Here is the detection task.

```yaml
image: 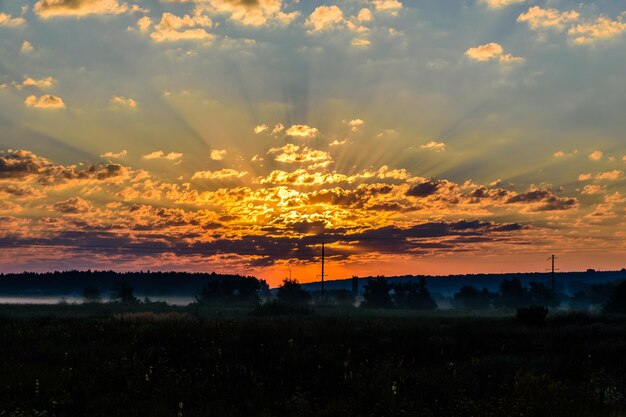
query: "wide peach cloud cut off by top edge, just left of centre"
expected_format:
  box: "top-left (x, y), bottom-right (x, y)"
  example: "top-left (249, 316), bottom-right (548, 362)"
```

top-left (191, 0), bottom-right (300, 27)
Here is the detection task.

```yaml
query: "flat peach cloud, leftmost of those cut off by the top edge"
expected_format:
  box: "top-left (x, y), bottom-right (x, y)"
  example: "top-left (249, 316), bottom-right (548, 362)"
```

top-left (34, 0), bottom-right (133, 19)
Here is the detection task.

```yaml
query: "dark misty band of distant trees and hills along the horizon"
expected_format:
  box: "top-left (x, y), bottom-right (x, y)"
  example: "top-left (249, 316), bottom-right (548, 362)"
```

top-left (0, 269), bottom-right (626, 309)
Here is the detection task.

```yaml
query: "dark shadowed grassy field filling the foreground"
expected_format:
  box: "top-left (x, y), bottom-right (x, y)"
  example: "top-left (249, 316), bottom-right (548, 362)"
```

top-left (0, 305), bottom-right (626, 417)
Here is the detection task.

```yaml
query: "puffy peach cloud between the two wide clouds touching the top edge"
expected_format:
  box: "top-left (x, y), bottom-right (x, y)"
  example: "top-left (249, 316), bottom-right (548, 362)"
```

top-left (149, 12), bottom-right (215, 43)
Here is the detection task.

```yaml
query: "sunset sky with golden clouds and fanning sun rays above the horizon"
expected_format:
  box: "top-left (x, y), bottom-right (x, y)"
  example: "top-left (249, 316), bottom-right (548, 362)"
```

top-left (0, 0), bottom-right (626, 285)
